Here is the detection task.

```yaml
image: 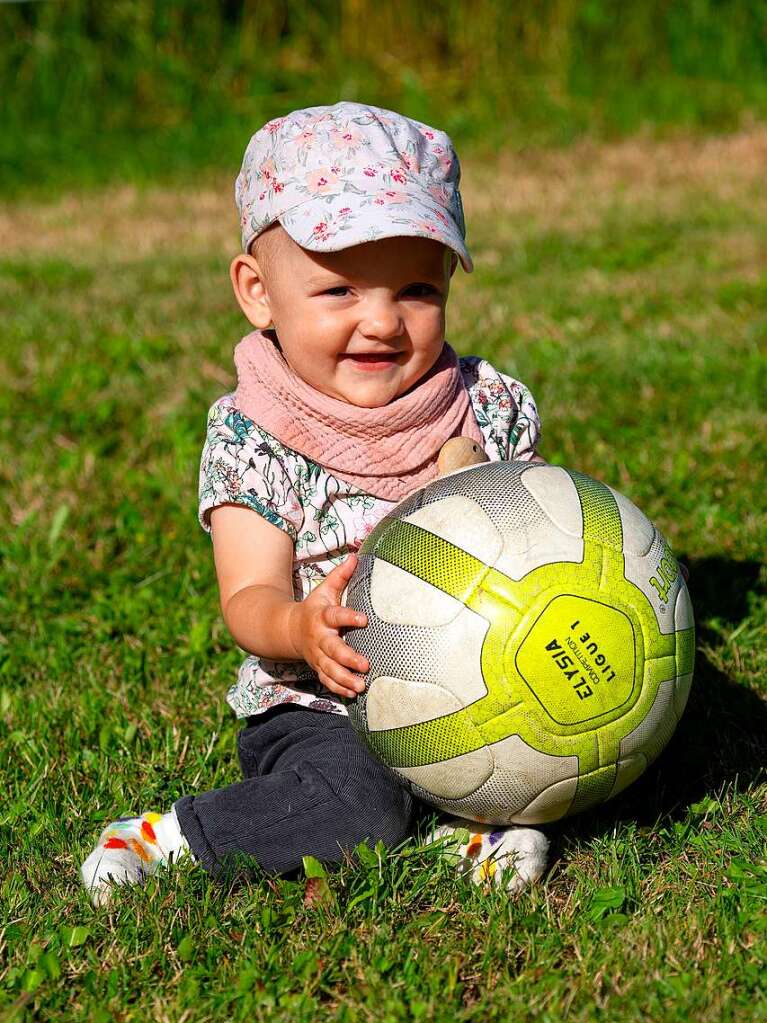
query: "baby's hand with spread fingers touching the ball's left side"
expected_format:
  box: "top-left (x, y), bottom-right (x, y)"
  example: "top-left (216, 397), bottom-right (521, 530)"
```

top-left (291, 554), bottom-right (370, 697)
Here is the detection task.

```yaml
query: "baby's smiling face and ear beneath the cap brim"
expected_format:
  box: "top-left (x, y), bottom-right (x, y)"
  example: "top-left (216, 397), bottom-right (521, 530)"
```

top-left (232, 227), bottom-right (455, 408)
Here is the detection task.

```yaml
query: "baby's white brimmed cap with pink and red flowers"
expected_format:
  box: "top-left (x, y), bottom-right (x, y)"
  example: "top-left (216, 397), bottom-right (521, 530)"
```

top-left (234, 102), bottom-right (472, 272)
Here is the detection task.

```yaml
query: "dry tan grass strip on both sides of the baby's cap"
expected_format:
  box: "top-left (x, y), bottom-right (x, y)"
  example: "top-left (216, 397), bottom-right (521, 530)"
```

top-left (0, 125), bottom-right (767, 265)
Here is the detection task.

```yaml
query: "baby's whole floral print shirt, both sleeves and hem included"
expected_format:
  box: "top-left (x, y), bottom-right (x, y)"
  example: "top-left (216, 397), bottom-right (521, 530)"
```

top-left (199, 356), bottom-right (540, 717)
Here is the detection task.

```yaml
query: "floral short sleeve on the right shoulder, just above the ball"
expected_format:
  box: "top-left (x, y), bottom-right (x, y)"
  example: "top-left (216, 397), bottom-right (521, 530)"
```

top-left (460, 356), bottom-right (541, 461)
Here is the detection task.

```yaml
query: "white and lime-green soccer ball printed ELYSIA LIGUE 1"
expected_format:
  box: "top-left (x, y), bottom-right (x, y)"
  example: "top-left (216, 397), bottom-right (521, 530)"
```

top-left (346, 461), bottom-right (694, 825)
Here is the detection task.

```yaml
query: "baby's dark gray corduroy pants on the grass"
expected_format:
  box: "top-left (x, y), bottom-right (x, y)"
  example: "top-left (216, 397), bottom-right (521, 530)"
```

top-left (176, 707), bottom-right (413, 876)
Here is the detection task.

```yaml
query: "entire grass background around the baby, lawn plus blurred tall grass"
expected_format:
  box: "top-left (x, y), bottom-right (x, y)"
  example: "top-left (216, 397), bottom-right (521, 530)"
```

top-left (0, 0), bottom-right (767, 1023)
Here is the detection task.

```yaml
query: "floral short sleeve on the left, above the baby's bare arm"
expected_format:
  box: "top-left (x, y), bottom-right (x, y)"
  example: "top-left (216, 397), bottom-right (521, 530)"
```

top-left (198, 395), bottom-right (304, 540)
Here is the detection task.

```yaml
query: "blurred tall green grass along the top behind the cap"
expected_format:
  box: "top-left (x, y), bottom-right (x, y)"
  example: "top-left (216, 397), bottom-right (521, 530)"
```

top-left (0, 0), bottom-right (767, 193)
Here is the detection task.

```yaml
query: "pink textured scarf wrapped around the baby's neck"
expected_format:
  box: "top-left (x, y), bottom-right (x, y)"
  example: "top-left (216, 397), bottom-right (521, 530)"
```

top-left (234, 330), bottom-right (482, 501)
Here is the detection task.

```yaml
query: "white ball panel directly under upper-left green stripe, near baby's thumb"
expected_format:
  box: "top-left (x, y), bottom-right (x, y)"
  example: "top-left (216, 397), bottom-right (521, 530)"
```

top-left (370, 558), bottom-right (463, 628)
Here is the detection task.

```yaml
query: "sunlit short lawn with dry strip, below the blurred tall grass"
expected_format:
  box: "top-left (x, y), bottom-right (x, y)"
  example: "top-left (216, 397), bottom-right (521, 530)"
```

top-left (0, 126), bottom-right (767, 1023)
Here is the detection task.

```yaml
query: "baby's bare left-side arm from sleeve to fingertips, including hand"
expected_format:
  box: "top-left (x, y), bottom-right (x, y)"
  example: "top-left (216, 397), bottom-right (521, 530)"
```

top-left (211, 504), bottom-right (370, 697)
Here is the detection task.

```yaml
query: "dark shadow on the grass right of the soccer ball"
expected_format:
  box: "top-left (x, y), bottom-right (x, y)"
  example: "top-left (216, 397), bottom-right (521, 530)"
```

top-left (555, 558), bottom-right (767, 844)
